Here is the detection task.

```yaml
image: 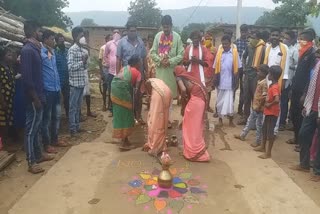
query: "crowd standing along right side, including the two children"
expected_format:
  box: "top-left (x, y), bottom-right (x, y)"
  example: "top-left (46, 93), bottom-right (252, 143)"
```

top-left (231, 25), bottom-right (320, 181)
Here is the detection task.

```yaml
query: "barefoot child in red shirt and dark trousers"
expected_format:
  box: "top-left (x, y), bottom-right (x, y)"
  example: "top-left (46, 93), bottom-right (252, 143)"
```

top-left (255, 66), bottom-right (282, 159)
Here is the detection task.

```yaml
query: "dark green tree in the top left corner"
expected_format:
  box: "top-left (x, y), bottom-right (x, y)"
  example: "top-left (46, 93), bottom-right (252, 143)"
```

top-left (1, 0), bottom-right (72, 29)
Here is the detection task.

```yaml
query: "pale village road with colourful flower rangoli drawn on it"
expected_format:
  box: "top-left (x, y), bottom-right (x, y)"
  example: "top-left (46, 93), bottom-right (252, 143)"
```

top-left (0, 94), bottom-right (320, 214)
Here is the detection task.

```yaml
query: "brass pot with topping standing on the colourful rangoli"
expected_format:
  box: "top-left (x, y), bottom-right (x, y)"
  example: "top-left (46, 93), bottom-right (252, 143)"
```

top-left (158, 153), bottom-right (173, 189)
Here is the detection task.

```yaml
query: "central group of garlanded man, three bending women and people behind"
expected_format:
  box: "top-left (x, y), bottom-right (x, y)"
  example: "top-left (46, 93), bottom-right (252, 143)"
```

top-left (99, 15), bottom-right (214, 161)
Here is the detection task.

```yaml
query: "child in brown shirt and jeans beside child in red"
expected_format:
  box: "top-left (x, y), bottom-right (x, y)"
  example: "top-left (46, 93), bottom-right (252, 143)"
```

top-left (234, 65), bottom-right (269, 147)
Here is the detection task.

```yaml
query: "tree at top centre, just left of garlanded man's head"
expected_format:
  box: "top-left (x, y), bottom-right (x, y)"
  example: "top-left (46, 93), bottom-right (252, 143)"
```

top-left (128, 0), bottom-right (162, 27)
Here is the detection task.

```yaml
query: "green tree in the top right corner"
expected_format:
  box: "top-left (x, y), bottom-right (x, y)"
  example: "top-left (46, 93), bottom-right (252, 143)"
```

top-left (256, 0), bottom-right (320, 27)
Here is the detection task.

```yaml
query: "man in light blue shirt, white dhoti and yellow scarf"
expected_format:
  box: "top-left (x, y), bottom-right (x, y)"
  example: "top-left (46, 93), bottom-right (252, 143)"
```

top-left (213, 35), bottom-right (242, 126)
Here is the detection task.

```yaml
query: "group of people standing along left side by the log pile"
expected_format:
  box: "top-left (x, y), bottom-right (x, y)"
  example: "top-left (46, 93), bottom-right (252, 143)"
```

top-left (0, 21), bottom-right (96, 174)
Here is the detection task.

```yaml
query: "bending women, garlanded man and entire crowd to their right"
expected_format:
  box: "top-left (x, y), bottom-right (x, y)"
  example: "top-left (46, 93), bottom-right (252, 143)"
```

top-left (102, 16), bottom-right (320, 181)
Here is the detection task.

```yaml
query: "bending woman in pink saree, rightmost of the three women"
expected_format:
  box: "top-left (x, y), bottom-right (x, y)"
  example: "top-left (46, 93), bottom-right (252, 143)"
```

top-left (175, 66), bottom-right (210, 162)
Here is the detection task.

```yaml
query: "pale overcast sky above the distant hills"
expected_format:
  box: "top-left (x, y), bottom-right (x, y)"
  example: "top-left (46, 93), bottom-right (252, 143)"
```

top-left (64, 0), bottom-right (274, 12)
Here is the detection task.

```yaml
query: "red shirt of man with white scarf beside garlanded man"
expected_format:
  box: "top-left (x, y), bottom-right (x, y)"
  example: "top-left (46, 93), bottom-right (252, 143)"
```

top-left (183, 45), bottom-right (213, 82)
